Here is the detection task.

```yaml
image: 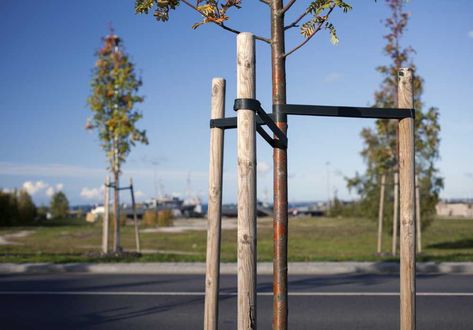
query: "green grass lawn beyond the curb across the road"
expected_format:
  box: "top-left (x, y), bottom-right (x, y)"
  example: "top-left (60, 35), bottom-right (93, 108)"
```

top-left (0, 218), bottom-right (473, 263)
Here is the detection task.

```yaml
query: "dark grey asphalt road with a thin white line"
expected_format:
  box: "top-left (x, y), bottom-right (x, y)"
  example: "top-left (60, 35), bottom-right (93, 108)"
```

top-left (0, 274), bottom-right (473, 330)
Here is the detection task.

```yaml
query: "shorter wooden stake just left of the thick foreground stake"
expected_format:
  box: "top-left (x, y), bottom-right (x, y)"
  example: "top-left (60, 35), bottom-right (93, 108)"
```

top-left (204, 78), bottom-right (225, 330)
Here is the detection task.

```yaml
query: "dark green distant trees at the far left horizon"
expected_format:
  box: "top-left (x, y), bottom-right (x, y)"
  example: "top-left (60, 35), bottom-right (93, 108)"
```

top-left (0, 189), bottom-right (69, 226)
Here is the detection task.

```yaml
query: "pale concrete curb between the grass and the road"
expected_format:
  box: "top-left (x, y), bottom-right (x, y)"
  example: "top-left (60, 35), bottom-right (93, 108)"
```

top-left (0, 262), bottom-right (473, 275)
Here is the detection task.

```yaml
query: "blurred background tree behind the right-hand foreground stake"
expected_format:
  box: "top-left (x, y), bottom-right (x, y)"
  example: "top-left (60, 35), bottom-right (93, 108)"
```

top-left (348, 0), bottom-right (443, 230)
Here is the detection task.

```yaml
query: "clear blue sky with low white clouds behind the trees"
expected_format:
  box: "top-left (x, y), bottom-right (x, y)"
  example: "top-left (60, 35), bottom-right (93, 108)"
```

top-left (0, 0), bottom-right (473, 204)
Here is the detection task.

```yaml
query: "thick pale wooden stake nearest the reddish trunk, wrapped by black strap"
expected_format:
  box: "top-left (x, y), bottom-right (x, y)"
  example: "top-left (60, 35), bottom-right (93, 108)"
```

top-left (237, 32), bottom-right (256, 330)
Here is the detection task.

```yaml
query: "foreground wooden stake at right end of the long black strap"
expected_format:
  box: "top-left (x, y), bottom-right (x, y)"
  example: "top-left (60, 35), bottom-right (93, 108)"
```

top-left (398, 68), bottom-right (416, 330)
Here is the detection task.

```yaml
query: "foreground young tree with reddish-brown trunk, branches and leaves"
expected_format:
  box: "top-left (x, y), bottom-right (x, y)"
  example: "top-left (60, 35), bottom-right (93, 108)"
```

top-left (135, 0), bottom-right (351, 329)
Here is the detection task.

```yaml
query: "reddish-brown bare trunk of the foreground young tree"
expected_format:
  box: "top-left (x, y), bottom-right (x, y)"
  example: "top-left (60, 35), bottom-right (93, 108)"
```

top-left (271, 0), bottom-right (288, 329)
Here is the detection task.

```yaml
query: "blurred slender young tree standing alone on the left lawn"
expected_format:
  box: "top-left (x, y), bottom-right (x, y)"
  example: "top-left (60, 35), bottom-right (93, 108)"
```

top-left (87, 32), bottom-right (148, 252)
